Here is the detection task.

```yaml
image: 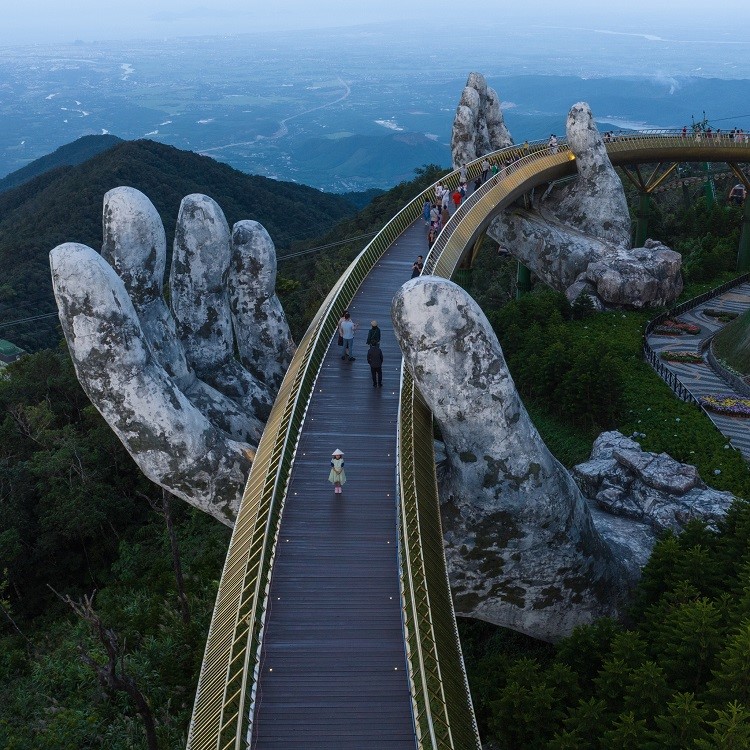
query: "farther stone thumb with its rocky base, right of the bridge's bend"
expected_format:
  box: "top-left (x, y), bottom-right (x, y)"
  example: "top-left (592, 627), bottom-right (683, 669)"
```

top-left (487, 102), bottom-right (682, 309)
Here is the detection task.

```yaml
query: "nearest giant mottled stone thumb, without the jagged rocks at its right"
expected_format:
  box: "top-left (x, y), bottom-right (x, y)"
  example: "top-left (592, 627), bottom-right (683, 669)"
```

top-left (392, 276), bottom-right (633, 640)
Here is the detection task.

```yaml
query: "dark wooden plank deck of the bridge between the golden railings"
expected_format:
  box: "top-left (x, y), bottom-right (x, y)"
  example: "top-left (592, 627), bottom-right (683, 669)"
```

top-left (251, 220), bottom-right (427, 750)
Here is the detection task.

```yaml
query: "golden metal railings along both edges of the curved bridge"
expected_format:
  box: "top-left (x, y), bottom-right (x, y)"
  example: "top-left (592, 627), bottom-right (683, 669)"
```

top-left (188, 133), bottom-right (750, 750)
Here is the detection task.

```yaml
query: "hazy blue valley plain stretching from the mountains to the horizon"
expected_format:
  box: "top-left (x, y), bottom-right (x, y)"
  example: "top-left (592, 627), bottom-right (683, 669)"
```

top-left (0, 25), bottom-right (750, 192)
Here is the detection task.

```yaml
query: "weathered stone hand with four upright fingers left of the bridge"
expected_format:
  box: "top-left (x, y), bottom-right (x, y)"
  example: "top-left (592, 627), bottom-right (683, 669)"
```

top-left (50, 187), bottom-right (294, 525)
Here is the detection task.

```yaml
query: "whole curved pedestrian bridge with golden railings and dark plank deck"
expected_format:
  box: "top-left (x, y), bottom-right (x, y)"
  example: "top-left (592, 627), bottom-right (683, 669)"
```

top-left (188, 133), bottom-right (750, 750)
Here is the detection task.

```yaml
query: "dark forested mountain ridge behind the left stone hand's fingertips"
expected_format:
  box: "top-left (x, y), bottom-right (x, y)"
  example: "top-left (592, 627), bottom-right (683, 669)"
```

top-left (0, 140), bottom-right (356, 351)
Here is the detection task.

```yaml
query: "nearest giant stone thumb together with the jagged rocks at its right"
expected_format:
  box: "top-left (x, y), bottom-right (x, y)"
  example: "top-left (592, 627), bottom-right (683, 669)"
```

top-left (392, 276), bottom-right (735, 641)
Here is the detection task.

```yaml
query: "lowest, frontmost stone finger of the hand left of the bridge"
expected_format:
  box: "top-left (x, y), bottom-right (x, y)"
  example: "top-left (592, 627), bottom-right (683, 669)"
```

top-left (50, 243), bottom-right (252, 523)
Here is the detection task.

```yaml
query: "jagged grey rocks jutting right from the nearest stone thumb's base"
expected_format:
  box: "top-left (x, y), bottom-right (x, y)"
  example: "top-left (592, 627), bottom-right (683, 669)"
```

top-left (573, 432), bottom-right (735, 533)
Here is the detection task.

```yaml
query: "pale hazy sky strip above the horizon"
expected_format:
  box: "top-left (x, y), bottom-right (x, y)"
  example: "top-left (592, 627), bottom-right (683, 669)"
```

top-left (0, 0), bottom-right (750, 45)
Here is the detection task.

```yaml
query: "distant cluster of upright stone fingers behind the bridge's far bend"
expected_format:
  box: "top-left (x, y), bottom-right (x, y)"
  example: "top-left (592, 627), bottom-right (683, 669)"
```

top-left (451, 73), bottom-right (513, 169)
